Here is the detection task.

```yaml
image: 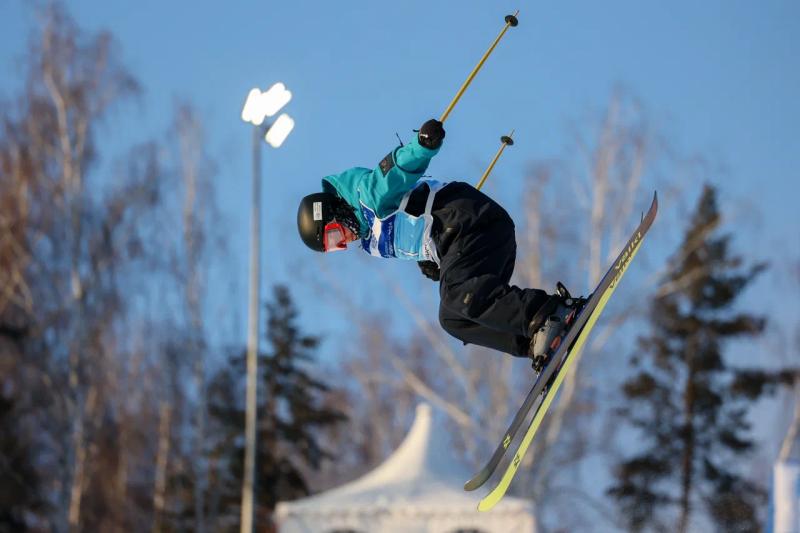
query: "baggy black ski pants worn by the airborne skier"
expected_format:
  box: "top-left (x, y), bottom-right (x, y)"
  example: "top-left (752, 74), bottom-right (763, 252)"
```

top-left (433, 182), bottom-right (548, 356)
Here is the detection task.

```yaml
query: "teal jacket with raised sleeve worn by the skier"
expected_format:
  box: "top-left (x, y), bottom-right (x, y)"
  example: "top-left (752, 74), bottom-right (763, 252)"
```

top-left (322, 138), bottom-right (439, 236)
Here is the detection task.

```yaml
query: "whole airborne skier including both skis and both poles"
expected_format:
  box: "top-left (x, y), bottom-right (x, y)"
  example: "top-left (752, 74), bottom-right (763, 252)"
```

top-left (297, 12), bottom-right (658, 504)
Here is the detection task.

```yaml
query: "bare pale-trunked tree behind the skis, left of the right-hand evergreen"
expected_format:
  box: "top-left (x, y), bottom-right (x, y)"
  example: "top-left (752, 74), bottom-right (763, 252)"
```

top-left (504, 91), bottom-right (658, 526)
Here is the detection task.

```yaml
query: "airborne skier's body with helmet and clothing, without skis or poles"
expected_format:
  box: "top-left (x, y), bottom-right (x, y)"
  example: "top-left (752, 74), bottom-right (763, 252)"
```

top-left (297, 119), bottom-right (583, 364)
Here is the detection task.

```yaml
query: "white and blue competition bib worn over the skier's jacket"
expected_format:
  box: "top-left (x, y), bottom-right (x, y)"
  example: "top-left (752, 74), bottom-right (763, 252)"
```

top-left (360, 179), bottom-right (447, 265)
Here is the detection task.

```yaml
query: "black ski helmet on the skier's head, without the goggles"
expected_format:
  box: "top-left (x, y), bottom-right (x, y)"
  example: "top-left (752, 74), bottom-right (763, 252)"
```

top-left (297, 192), bottom-right (359, 252)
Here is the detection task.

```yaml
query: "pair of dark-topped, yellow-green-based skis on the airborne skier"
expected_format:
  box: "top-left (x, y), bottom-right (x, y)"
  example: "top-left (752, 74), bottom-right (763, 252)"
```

top-left (472, 194), bottom-right (658, 511)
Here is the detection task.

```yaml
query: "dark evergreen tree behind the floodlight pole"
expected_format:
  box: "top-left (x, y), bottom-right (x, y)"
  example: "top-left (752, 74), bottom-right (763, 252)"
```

top-left (209, 285), bottom-right (346, 530)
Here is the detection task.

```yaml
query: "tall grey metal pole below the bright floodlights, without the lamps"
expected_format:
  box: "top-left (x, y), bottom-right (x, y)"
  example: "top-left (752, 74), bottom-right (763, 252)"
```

top-left (239, 126), bottom-right (261, 533)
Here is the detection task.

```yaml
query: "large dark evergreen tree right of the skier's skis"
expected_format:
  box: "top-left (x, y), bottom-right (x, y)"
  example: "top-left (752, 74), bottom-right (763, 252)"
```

top-left (608, 186), bottom-right (766, 532)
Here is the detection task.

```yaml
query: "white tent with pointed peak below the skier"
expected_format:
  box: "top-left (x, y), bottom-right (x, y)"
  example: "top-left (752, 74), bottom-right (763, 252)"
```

top-left (275, 404), bottom-right (534, 533)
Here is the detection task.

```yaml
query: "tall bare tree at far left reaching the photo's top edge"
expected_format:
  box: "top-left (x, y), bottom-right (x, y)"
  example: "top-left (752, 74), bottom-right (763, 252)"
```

top-left (10, 4), bottom-right (141, 529)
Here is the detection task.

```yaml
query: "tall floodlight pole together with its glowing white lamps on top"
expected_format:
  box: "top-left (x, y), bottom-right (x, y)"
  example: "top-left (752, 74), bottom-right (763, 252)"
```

top-left (239, 83), bottom-right (294, 533)
